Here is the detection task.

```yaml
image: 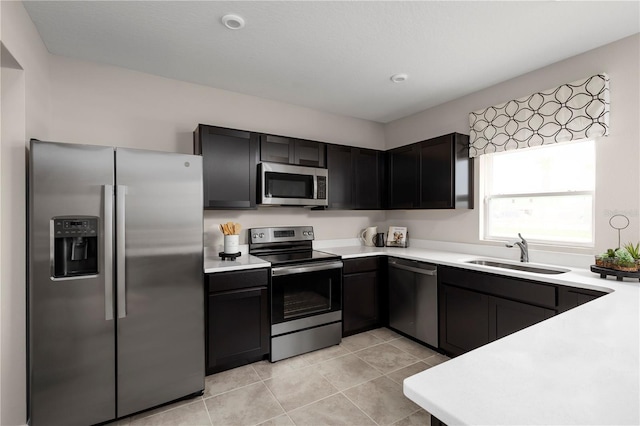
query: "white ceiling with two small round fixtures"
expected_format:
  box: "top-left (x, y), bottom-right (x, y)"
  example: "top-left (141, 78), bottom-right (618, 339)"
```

top-left (24, 1), bottom-right (640, 123)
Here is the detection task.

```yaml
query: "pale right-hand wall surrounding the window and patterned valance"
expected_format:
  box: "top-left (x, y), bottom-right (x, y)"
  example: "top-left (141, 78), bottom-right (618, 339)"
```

top-left (385, 34), bottom-right (640, 253)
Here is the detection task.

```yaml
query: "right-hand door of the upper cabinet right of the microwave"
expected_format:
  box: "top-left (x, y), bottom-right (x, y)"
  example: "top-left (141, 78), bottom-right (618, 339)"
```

top-left (353, 148), bottom-right (384, 210)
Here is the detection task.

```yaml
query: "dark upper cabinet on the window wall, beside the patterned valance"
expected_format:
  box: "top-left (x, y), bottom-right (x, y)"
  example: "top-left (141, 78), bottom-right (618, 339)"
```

top-left (387, 133), bottom-right (473, 209)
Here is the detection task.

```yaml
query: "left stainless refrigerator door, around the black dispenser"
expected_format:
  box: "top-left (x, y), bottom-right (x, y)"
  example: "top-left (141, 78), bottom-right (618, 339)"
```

top-left (28, 141), bottom-right (116, 426)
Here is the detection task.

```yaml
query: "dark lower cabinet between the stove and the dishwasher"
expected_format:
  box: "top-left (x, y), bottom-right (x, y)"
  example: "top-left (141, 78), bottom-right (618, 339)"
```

top-left (342, 257), bottom-right (383, 337)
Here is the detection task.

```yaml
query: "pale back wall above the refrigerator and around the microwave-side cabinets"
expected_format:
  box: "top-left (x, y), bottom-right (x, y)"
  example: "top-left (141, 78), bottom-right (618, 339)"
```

top-left (47, 56), bottom-right (384, 245)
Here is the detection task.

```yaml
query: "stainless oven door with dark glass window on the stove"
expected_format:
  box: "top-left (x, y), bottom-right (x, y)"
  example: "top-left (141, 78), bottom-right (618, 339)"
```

top-left (271, 261), bottom-right (342, 325)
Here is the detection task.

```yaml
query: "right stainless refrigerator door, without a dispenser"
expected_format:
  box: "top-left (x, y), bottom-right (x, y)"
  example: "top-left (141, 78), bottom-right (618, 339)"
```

top-left (116, 148), bottom-right (205, 417)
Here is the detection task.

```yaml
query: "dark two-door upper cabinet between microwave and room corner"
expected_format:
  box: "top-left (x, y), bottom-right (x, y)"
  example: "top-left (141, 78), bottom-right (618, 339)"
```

top-left (327, 145), bottom-right (384, 210)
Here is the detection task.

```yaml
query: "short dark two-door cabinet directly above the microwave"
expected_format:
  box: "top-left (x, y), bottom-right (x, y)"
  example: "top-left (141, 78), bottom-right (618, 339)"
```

top-left (260, 135), bottom-right (326, 167)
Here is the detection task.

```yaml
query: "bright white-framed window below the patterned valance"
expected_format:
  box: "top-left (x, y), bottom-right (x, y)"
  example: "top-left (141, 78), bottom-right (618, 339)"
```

top-left (481, 140), bottom-right (595, 246)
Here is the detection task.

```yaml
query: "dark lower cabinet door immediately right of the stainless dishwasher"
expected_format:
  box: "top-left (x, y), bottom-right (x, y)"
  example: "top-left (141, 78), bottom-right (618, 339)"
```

top-left (438, 284), bottom-right (490, 356)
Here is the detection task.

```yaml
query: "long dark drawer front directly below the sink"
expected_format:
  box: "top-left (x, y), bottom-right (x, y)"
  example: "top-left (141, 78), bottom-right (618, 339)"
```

top-left (438, 268), bottom-right (557, 308)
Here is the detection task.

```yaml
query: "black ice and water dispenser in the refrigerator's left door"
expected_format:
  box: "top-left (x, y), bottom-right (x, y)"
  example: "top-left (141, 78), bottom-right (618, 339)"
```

top-left (52, 216), bottom-right (98, 278)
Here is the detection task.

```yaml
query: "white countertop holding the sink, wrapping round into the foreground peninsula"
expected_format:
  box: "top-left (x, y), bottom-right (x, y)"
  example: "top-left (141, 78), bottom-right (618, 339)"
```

top-left (320, 246), bottom-right (640, 426)
